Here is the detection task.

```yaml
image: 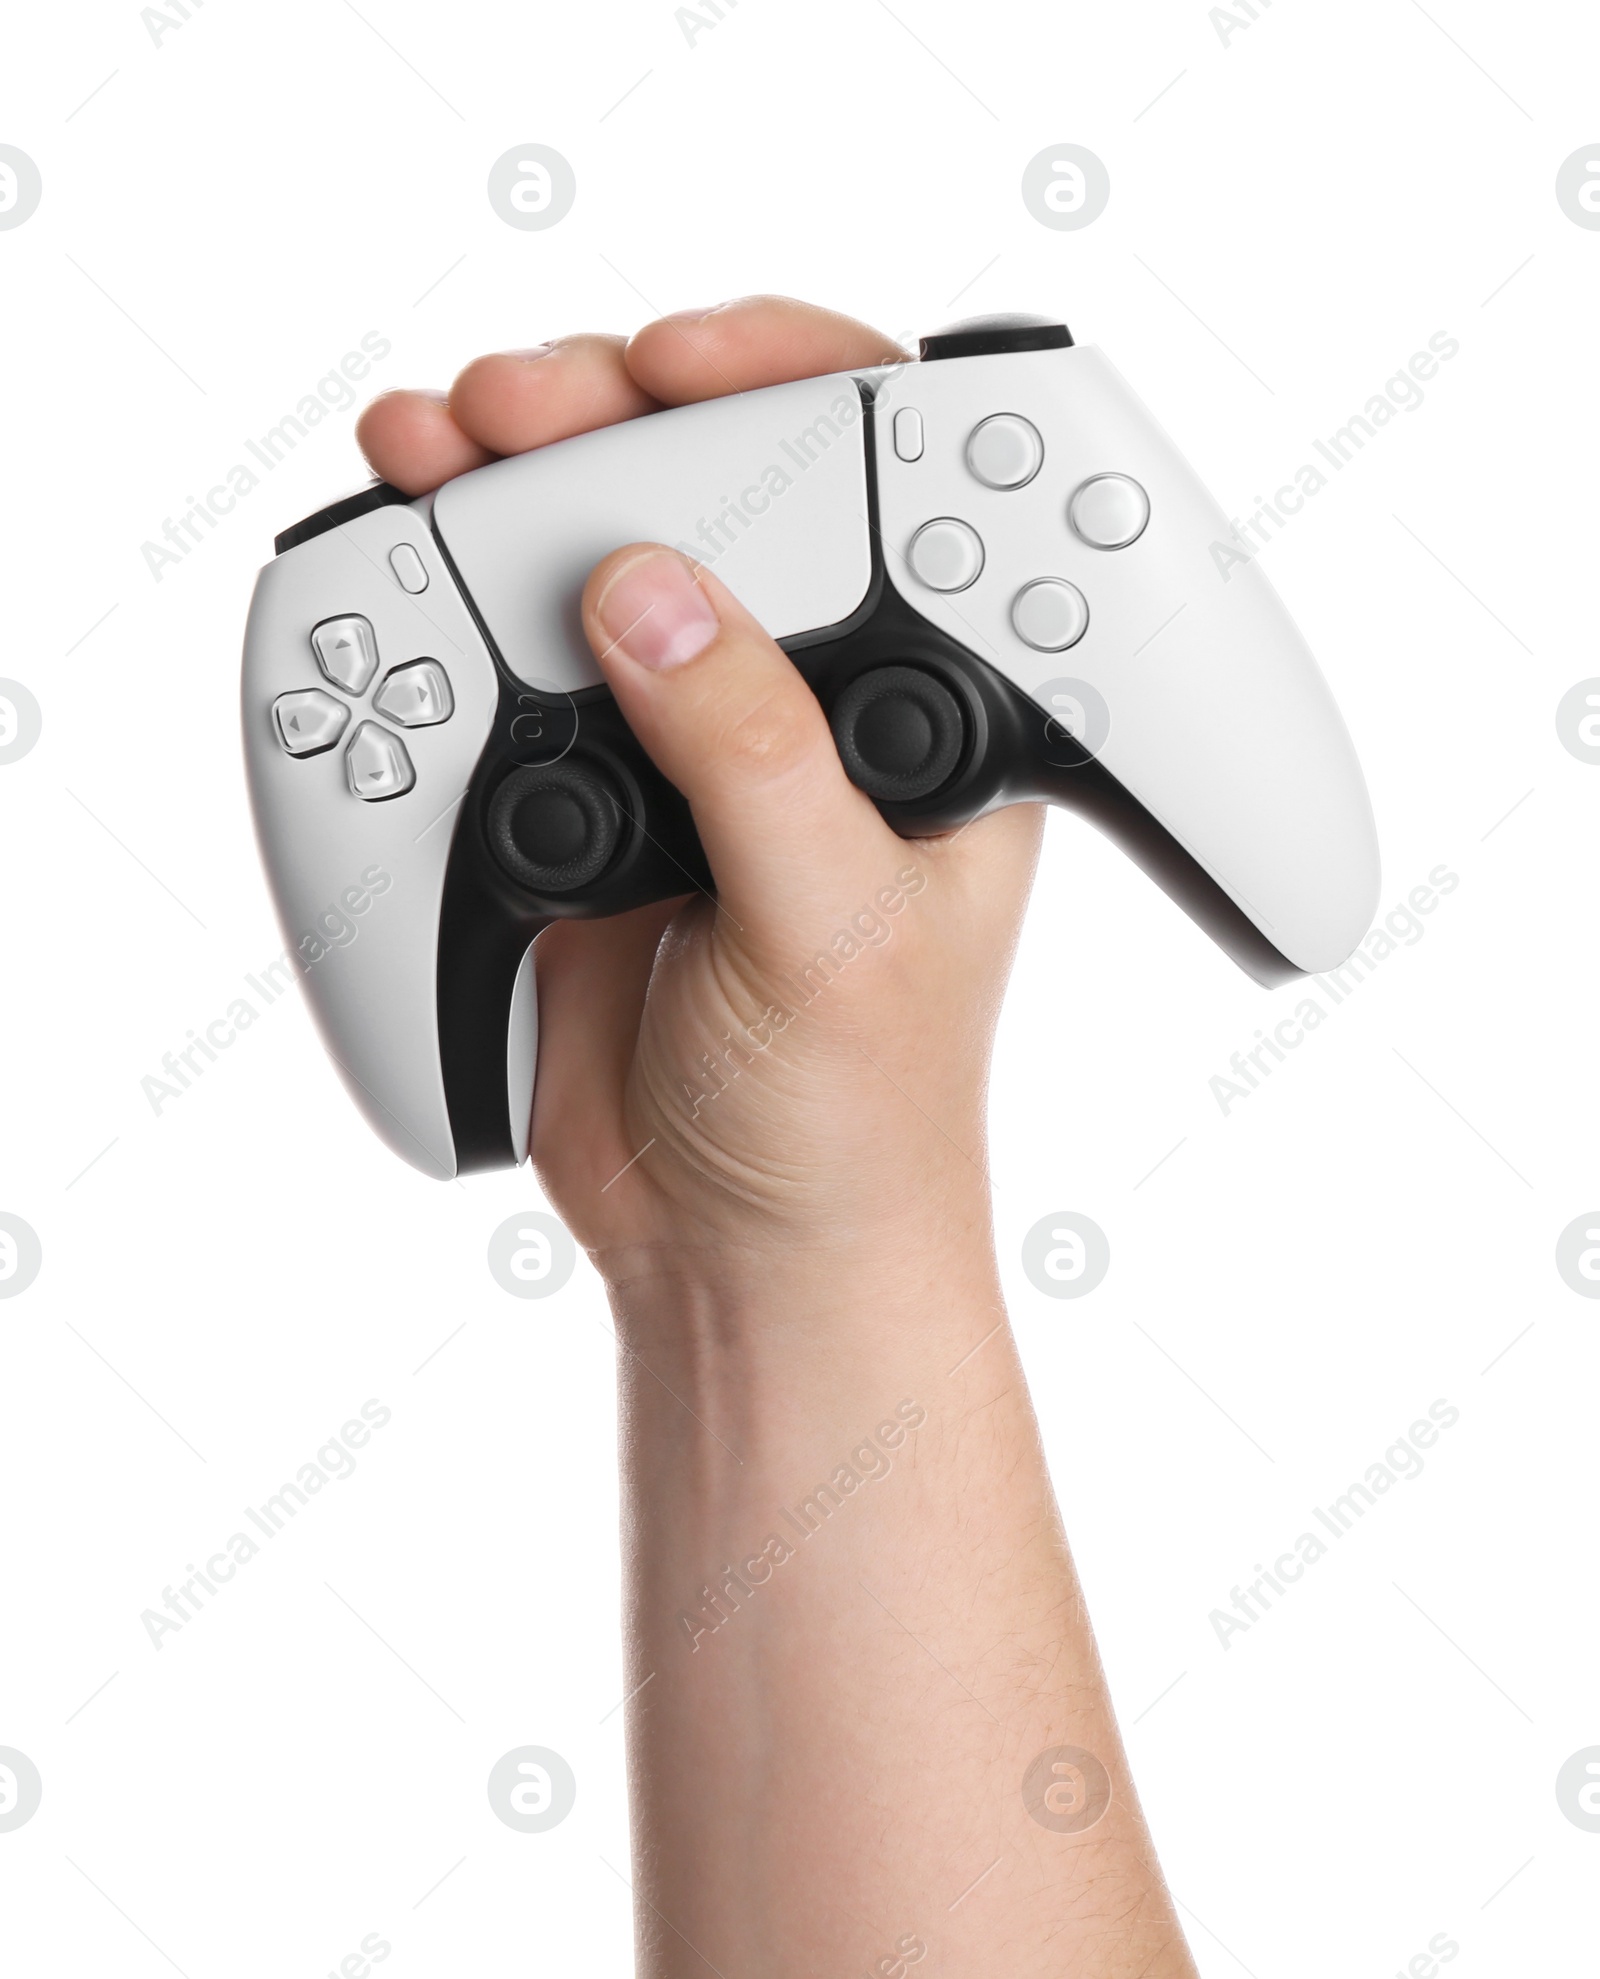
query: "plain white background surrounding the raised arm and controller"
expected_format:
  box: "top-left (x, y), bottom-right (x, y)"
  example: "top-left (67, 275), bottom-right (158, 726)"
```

top-left (0, 0), bottom-right (1600, 1979)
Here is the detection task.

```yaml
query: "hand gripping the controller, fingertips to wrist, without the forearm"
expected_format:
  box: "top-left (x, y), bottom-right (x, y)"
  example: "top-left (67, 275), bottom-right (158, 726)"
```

top-left (358, 297), bottom-right (1040, 1269)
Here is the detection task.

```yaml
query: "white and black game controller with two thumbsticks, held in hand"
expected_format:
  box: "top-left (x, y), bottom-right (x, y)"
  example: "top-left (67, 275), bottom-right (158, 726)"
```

top-left (244, 317), bottom-right (1378, 1178)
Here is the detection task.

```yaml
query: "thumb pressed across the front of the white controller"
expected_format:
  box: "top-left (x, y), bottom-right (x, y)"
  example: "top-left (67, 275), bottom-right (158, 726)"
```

top-left (582, 544), bottom-right (899, 932)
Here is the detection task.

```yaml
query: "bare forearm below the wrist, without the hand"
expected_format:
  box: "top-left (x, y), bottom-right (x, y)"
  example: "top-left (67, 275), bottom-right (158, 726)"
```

top-left (614, 1211), bottom-right (1192, 1979)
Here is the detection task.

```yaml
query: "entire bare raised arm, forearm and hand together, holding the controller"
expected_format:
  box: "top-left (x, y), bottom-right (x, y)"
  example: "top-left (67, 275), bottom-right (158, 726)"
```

top-left (360, 299), bottom-right (1194, 1979)
